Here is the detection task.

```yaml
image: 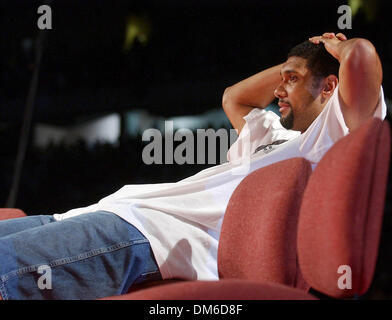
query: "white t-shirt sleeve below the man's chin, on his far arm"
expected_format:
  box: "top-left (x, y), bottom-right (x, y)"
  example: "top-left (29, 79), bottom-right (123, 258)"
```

top-left (227, 108), bottom-right (300, 162)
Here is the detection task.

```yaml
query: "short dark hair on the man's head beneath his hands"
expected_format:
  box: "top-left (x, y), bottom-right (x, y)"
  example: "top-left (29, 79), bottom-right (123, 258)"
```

top-left (287, 40), bottom-right (339, 78)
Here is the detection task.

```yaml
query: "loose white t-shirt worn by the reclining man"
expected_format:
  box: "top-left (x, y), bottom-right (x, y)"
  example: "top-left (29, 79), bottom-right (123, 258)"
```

top-left (54, 84), bottom-right (386, 280)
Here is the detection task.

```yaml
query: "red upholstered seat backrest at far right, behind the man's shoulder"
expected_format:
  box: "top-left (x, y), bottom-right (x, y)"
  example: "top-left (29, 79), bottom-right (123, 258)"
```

top-left (298, 118), bottom-right (390, 298)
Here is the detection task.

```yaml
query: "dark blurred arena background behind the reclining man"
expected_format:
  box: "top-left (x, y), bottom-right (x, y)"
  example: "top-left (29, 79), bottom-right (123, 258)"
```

top-left (0, 0), bottom-right (392, 299)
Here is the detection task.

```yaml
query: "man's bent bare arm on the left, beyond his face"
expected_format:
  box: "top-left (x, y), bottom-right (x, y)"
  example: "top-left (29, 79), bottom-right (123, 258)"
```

top-left (222, 64), bottom-right (282, 134)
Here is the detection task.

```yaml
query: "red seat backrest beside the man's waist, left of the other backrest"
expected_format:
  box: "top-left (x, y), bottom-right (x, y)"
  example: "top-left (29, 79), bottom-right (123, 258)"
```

top-left (218, 158), bottom-right (312, 290)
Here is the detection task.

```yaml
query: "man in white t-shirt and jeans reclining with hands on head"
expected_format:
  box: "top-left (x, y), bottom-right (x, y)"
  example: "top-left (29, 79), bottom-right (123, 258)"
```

top-left (0, 33), bottom-right (386, 299)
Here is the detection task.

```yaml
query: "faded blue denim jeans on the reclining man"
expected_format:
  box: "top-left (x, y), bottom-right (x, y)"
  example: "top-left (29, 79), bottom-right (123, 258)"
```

top-left (0, 211), bottom-right (162, 300)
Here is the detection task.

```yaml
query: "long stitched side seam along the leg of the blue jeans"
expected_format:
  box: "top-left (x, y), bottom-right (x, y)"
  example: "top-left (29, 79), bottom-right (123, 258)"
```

top-left (0, 239), bottom-right (148, 282)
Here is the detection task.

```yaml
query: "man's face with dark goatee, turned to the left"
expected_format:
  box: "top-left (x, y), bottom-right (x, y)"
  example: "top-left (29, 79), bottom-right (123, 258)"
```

top-left (274, 57), bottom-right (322, 132)
